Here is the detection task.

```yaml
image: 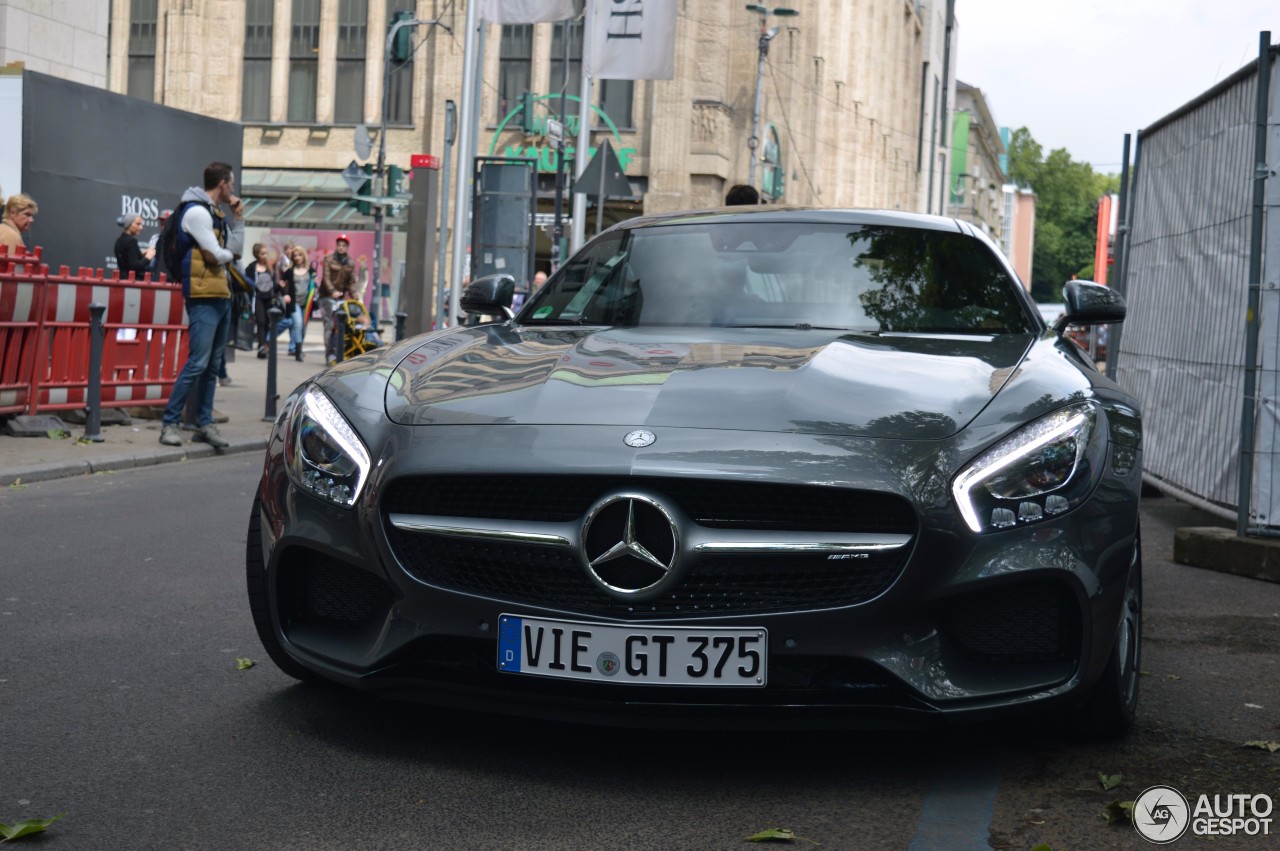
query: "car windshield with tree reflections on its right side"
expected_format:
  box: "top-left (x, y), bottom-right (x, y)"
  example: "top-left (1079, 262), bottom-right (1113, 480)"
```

top-left (517, 221), bottom-right (1032, 334)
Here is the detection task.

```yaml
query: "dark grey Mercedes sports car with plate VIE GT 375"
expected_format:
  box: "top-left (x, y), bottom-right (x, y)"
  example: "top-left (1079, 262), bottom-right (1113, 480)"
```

top-left (246, 207), bottom-right (1142, 735)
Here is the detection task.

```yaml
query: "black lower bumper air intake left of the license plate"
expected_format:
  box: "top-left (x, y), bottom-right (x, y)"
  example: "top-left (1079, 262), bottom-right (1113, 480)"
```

top-left (279, 549), bottom-right (393, 630)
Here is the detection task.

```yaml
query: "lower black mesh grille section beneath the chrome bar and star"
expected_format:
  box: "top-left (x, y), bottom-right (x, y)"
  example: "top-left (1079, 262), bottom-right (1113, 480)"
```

top-left (388, 526), bottom-right (910, 618)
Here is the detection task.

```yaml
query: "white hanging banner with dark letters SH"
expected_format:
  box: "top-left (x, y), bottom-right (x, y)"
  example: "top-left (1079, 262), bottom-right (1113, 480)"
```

top-left (585, 0), bottom-right (676, 79)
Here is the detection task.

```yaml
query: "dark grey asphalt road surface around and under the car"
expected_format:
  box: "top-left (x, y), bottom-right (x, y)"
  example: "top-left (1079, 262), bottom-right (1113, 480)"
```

top-left (0, 456), bottom-right (1280, 851)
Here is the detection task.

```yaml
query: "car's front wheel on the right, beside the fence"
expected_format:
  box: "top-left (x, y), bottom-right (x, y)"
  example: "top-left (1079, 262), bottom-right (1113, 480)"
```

top-left (1073, 532), bottom-right (1142, 738)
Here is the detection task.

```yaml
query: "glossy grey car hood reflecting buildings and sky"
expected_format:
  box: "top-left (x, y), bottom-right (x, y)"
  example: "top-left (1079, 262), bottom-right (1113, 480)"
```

top-left (385, 325), bottom-right (1034, 440)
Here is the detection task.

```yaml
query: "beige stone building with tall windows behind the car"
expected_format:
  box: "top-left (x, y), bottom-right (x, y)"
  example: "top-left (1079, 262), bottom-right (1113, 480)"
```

top-left (108, 0), bottom-right (955, 268)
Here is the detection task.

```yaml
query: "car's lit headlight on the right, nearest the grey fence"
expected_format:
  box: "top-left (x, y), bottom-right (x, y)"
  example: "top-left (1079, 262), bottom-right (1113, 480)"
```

top-left (951, 402), bottom-right (1105, 532)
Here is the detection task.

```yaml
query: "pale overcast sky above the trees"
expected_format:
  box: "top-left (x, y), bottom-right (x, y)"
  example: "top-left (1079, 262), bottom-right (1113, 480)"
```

top-left (955, 0), bottom-right (1280, 174)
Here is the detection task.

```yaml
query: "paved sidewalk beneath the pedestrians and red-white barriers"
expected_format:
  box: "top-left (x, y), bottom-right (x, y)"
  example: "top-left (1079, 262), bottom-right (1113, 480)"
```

top-left (0, 339), bottom-right (324, 486)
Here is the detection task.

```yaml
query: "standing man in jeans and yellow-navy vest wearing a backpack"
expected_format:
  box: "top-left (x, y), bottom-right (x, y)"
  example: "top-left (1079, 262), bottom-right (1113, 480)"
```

top-left (160, 163), bottom-right (244, 449)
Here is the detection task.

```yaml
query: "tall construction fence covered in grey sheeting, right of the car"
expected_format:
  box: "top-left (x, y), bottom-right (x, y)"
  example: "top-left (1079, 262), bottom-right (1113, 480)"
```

top-left (1115, 39), bottom-right (1280, 530)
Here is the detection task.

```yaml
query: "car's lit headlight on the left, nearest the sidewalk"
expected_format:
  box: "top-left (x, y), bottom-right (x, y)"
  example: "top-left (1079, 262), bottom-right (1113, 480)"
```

top-left (284, 388), bottom-right (370, 508)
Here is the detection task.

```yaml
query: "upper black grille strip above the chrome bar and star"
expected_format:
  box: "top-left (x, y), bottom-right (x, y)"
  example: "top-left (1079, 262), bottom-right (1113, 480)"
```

top-left (383, 475), bottom-right (916, 535)
